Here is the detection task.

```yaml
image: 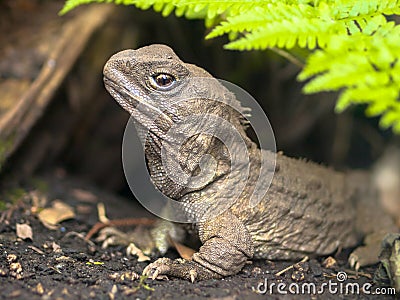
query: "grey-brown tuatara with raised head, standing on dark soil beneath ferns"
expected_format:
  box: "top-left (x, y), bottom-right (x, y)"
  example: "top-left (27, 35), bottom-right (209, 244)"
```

top-left (103, 45), bottom-right (397, 281)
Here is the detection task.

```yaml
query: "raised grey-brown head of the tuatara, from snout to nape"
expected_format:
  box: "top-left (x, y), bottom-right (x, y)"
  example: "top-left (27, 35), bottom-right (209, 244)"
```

top-left (103, 45), bottom-right (250, 143)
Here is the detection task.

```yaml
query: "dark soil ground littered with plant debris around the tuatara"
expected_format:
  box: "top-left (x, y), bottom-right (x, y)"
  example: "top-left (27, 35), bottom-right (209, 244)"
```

top-left (0, 170), bottom-right (396, 299)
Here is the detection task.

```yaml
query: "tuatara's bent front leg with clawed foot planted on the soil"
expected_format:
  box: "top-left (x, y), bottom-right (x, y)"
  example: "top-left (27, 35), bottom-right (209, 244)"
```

top-left (143, 211), bottom-right (253, 282)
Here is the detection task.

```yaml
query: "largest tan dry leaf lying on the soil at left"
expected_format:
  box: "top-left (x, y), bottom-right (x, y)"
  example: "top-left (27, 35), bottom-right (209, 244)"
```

top-left (38, 200), bottom-right (75, 229)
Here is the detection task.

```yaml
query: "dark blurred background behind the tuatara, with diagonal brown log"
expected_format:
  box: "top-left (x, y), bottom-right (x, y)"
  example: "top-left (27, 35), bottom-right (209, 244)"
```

top-left (0, 0), bottom-right (398, 197)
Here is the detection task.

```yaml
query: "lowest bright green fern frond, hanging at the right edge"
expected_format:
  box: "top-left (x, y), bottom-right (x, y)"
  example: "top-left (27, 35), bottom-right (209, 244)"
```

top-left (298, 22), bottom-right (400, 133)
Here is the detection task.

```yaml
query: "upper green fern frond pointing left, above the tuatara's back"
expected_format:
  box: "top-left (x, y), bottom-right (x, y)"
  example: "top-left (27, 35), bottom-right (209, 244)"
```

top-left (211, 1), bottom-right (392, 50)
